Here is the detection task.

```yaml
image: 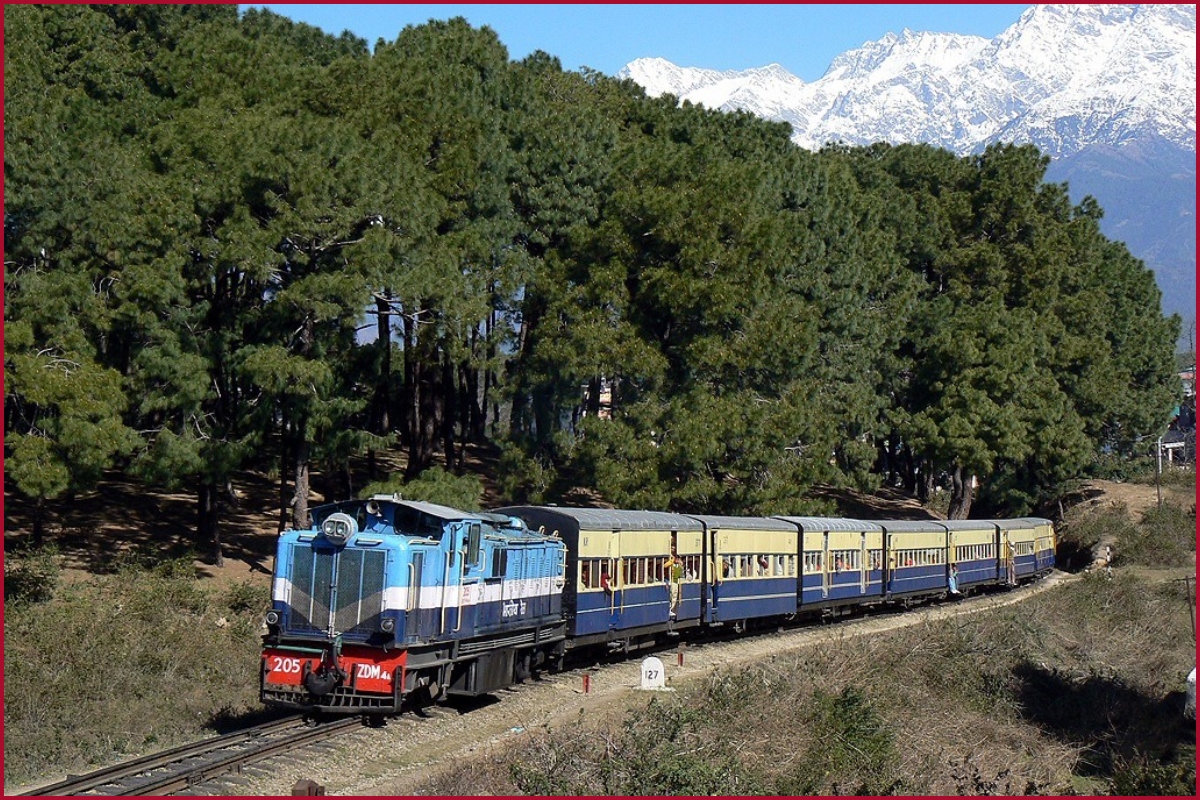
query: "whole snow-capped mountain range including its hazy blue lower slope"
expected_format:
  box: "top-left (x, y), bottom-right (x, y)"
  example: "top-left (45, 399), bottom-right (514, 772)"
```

top-left (618, 4), bottom-right (1196, 323)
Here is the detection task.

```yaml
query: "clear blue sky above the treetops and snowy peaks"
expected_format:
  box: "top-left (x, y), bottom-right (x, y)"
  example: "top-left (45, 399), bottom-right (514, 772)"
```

top-left (240, 2), bottom-right (1028, 82)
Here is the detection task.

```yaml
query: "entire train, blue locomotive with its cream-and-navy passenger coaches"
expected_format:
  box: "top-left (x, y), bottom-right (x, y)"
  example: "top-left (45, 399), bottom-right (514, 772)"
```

top-left (259, 494), bottom-right (1056, 720)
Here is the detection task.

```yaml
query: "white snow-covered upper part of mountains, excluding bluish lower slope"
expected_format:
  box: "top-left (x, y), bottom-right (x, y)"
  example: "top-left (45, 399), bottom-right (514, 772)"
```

top-left (618, 5), bottom-right (1196, 158)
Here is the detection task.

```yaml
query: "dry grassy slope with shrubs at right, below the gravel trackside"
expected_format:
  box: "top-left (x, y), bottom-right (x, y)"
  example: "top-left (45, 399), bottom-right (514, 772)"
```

top-left (419, 573), bottom-right (1194, 795)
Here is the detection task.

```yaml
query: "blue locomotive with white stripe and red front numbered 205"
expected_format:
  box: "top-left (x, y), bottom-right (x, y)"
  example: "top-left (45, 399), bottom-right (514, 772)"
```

top-left (260, 495), bottom-right (566, 714)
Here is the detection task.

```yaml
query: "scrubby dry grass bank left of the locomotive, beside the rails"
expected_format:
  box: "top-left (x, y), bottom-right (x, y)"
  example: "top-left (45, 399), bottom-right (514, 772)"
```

top-left (4, 563), bottom-right (262, 782)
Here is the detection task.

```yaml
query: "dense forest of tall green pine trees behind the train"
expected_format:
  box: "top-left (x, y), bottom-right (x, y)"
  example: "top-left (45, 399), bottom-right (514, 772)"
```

top-left (4, 5), bottom-right (1180, 560)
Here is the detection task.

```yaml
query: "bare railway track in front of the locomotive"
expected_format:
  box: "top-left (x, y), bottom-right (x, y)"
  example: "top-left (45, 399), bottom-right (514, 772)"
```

top-left (19, 715), bottom-right (362, 796)
